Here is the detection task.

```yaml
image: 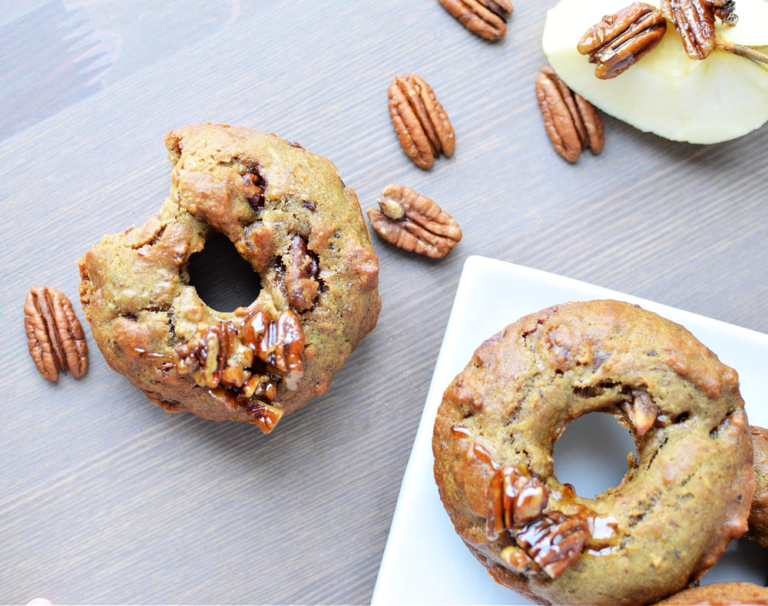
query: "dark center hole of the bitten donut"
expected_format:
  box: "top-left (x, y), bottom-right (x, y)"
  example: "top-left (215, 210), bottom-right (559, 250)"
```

top-left (188, 233), bottom-right (261, 313)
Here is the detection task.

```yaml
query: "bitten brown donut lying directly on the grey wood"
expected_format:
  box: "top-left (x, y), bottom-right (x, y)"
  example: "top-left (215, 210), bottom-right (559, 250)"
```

top-left (78, 124), bottom-right (381, 433)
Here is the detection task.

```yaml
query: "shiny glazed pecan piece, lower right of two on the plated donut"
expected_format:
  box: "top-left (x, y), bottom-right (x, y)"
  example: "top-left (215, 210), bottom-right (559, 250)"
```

top-left (514, 511), bottom-right (590, 579)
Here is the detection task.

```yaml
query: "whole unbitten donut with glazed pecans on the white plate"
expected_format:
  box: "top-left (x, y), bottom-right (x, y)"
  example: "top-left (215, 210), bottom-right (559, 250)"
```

top-left (433, 301), bottom-right (754, 604)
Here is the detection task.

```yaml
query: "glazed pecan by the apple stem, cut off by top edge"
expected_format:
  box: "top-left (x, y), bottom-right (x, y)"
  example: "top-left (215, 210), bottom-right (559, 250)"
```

top-left (661, 0), bottom-right (739, 60)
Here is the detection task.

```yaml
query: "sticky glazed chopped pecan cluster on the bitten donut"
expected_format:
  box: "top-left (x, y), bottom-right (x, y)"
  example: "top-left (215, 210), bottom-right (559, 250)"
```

top-left (175, 310), bottom-right (304, 433)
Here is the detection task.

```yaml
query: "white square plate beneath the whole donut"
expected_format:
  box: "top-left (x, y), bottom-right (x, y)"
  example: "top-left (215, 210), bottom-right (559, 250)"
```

top-left (372, 257), bottom-right (768, 605)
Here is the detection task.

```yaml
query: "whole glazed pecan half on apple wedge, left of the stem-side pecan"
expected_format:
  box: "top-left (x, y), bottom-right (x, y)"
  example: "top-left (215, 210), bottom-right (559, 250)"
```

top-left (576, 2), bottom-right (667, 80)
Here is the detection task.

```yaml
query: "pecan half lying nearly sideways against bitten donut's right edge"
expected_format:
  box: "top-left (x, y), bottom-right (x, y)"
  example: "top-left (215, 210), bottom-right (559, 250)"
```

top-left (368, 185), bottom-right (461, 259)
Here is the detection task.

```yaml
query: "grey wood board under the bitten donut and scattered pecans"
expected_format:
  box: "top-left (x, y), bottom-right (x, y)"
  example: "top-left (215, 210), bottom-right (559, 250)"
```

top-left (0, 0), bottom-right (768, 604)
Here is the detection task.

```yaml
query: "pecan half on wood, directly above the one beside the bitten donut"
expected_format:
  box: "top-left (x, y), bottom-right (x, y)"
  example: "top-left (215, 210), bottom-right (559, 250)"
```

top-left (389, 74), bottom-right (456, 170)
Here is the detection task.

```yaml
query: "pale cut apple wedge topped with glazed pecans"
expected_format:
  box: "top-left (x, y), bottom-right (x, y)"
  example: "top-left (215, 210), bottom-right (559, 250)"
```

top-left (542, 0), bottom-right (768, 144)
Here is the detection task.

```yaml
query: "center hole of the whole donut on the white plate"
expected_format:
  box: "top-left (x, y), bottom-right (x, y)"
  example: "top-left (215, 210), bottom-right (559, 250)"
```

top-left (554, 413), bottom-right (637, 499)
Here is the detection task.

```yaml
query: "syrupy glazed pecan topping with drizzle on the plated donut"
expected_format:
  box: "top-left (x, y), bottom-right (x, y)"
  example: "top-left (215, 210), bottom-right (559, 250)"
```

top-left (451, 425), bottom-right (617, 579)
